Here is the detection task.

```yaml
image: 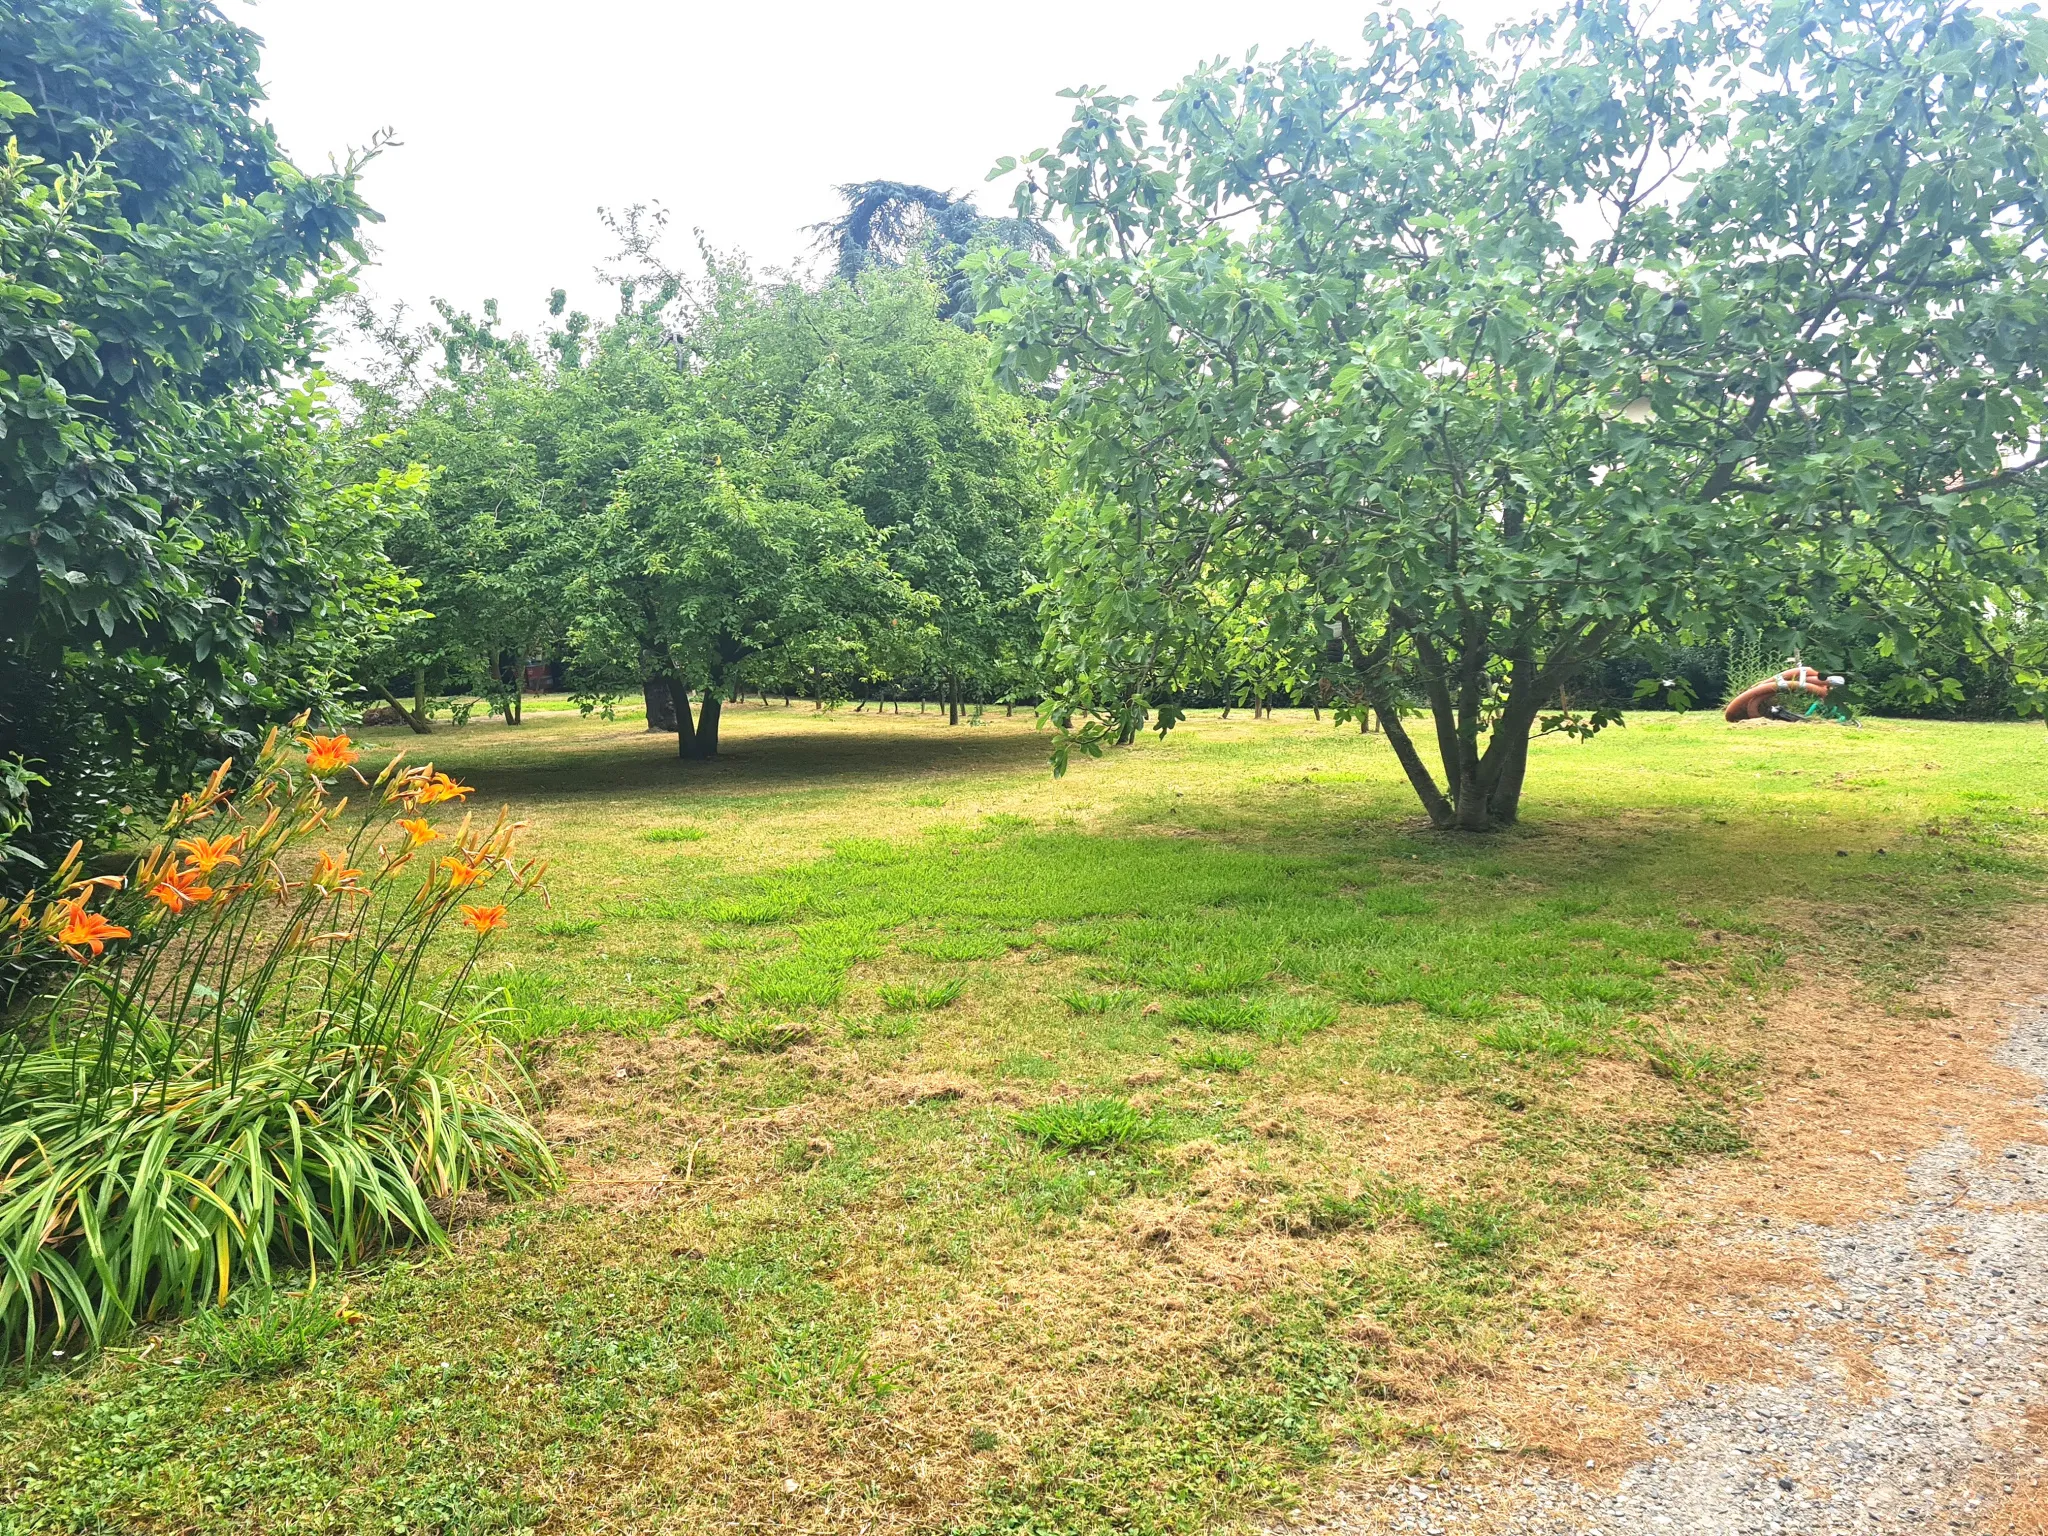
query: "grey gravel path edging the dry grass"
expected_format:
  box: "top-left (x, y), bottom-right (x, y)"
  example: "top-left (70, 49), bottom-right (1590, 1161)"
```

top-left (1286, 1004), bottom-right (2048, 1536)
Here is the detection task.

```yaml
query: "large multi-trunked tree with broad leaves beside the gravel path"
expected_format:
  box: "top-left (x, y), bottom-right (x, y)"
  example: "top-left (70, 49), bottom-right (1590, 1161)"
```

top-left (981, 0), bottom-right (2048, 829)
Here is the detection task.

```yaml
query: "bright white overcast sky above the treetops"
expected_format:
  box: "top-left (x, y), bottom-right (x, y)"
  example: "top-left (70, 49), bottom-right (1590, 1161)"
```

top-left (225, 0), bottom-right (1538, 326)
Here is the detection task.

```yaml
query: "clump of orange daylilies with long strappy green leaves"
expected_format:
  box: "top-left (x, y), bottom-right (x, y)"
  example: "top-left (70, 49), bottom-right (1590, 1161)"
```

top-left (0, 721), bottom-right (555, 1364)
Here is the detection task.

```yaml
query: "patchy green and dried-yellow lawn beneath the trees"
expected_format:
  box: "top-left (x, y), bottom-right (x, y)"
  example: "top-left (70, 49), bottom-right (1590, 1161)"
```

top-left (0, 705), bottom-right (2048, 1534)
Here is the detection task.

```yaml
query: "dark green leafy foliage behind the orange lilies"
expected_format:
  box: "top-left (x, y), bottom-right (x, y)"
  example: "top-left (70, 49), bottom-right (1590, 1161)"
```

top-left (0, 0), bottom-right (387, 868)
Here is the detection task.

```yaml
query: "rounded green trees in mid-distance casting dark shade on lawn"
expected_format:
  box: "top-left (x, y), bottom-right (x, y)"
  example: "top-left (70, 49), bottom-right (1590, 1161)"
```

top-left (352, 244), bottom-right (1047, 758)
